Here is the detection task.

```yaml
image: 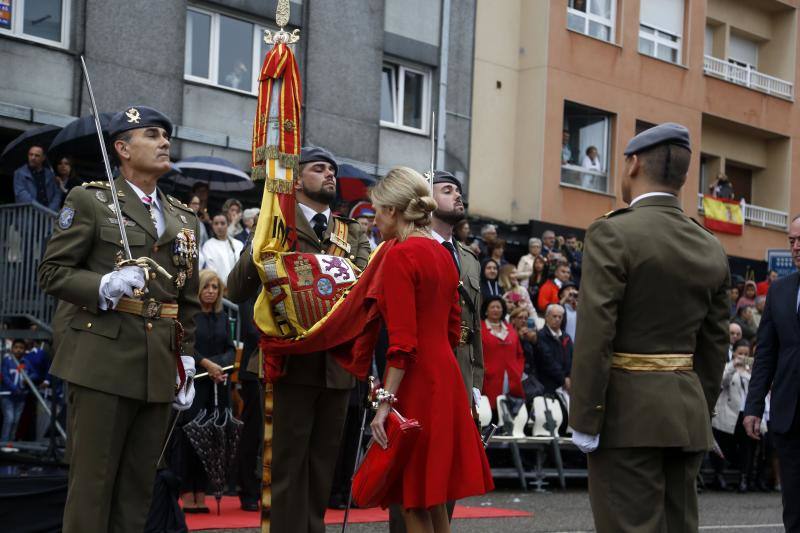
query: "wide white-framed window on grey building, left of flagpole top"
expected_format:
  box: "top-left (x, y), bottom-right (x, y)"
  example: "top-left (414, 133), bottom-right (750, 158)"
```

top-left (184, 8), bottom-right (278, 94)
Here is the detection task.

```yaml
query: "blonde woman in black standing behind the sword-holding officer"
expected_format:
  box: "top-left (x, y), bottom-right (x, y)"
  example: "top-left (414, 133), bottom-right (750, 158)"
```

top-left (172, 270), bottom-right (234, 513)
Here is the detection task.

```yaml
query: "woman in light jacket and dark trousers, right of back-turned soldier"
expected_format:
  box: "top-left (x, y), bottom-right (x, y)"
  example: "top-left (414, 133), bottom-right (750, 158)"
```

top-left (711, 339), bottom-right (755, 492)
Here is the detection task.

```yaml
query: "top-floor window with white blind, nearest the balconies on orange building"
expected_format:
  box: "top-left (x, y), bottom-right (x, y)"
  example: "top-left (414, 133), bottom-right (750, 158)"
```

top-left (639, 0), bottom-right (684, 63)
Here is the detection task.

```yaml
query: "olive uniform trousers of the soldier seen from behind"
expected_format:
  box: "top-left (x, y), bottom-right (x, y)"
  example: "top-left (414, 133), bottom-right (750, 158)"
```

top-left (587, 448), bottom-right (705, 533)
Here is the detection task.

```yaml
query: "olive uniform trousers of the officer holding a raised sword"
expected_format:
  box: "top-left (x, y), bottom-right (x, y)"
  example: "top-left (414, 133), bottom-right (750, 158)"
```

top-left (63, 383), bottom-right (171, 533)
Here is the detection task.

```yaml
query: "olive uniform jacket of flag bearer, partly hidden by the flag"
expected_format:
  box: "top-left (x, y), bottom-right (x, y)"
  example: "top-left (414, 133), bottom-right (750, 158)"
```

top-left (228, 209), bottom-right (370, 389)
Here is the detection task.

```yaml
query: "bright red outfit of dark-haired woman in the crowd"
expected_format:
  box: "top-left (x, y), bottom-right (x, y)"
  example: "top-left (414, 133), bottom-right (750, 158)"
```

top-left (481, 320), bottom-right (525, 411)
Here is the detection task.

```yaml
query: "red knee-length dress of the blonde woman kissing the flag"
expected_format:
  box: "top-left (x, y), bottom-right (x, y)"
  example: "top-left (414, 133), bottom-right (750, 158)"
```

top-left (378, 237), bottom-right (494, 509)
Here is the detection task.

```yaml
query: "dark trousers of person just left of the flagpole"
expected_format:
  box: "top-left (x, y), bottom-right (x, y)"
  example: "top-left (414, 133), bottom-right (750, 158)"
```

top-left (238, 379), bottom-right (264, 503)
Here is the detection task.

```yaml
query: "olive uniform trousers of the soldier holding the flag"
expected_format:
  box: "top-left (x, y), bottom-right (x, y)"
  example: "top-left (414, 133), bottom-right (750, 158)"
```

top-left (270, 380), bottom-right (350, 533)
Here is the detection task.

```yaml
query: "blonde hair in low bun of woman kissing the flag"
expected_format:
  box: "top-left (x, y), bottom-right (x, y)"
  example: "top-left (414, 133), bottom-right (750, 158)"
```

top-left (370, 167), bottom-right (436, 241)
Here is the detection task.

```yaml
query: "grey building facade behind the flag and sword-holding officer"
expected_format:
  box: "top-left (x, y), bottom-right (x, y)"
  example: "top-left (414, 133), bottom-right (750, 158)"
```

top-left (0, 0), bottom-right (475, 201)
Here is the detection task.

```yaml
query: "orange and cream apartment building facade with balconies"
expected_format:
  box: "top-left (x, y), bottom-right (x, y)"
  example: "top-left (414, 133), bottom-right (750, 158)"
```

top-left (470, 0), bottom-right (800, 261)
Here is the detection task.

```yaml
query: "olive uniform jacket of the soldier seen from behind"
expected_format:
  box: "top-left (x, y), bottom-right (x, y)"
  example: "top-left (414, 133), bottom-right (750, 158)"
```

top-left (569, 195), bottom-right (730, 451)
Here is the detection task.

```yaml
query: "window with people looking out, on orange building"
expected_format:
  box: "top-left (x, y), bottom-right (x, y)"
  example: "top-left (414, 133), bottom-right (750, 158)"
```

top-left (561, 102), bottom-right (613, 193)
